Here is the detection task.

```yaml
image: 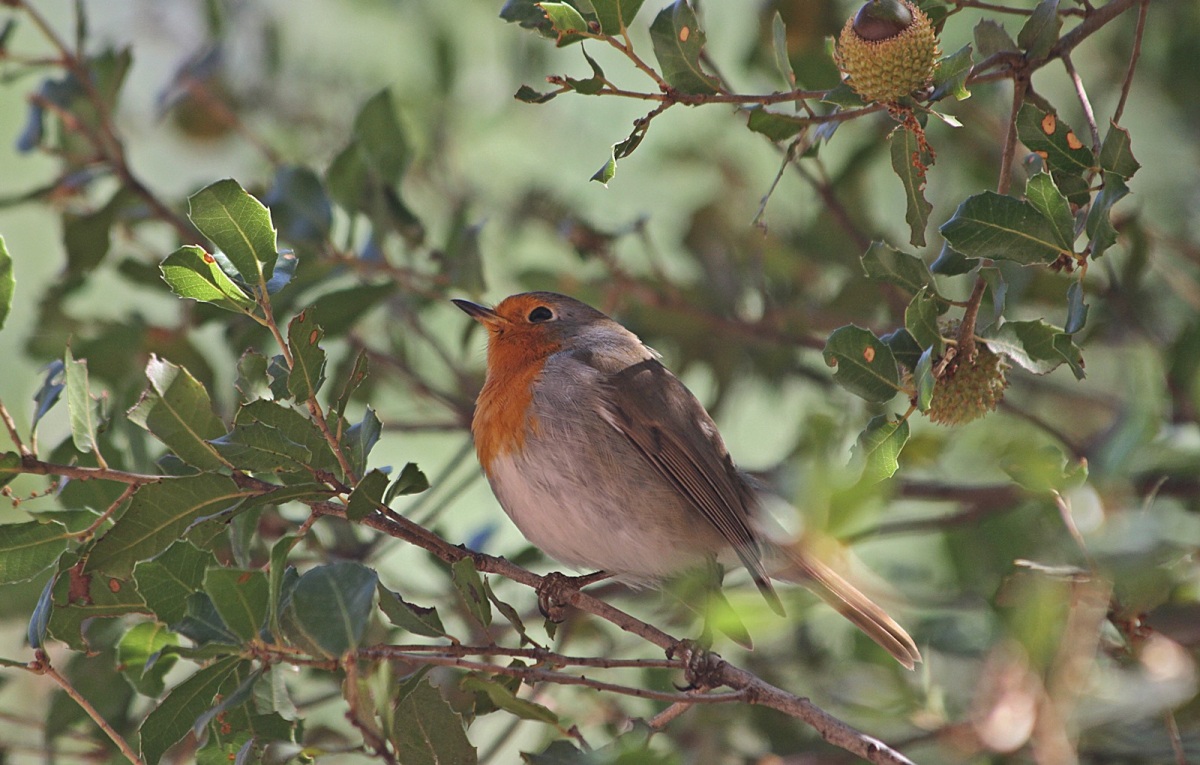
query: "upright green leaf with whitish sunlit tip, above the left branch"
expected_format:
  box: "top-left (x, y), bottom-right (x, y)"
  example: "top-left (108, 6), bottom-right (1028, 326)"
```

top-left (127, 355), bottom-right (229, 470)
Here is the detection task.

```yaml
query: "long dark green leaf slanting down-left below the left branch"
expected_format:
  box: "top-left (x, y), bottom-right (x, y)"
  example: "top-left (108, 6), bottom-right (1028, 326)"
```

top-left (86, 474), bottom-right (251, 577)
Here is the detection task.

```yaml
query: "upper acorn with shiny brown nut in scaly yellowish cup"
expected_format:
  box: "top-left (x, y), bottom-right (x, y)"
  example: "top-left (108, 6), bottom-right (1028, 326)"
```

top-left (834, 0), bottom-right (940, 103)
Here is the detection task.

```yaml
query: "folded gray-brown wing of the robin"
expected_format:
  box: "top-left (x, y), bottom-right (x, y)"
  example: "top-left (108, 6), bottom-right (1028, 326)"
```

top-left (601, 359), bottom-right (782, 614)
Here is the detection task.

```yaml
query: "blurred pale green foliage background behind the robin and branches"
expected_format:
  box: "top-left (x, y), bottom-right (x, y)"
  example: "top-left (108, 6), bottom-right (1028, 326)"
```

top-left (0, 0), bottom-right (1200, 761)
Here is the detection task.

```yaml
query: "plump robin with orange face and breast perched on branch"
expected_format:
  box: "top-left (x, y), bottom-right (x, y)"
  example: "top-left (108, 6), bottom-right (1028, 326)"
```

top-left (454, 293), bottom-right (920, 669)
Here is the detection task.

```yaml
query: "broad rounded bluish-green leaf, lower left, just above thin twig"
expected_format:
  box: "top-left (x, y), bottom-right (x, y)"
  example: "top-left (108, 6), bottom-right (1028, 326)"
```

top-left (280, 561), bottom-right (378, 657)
